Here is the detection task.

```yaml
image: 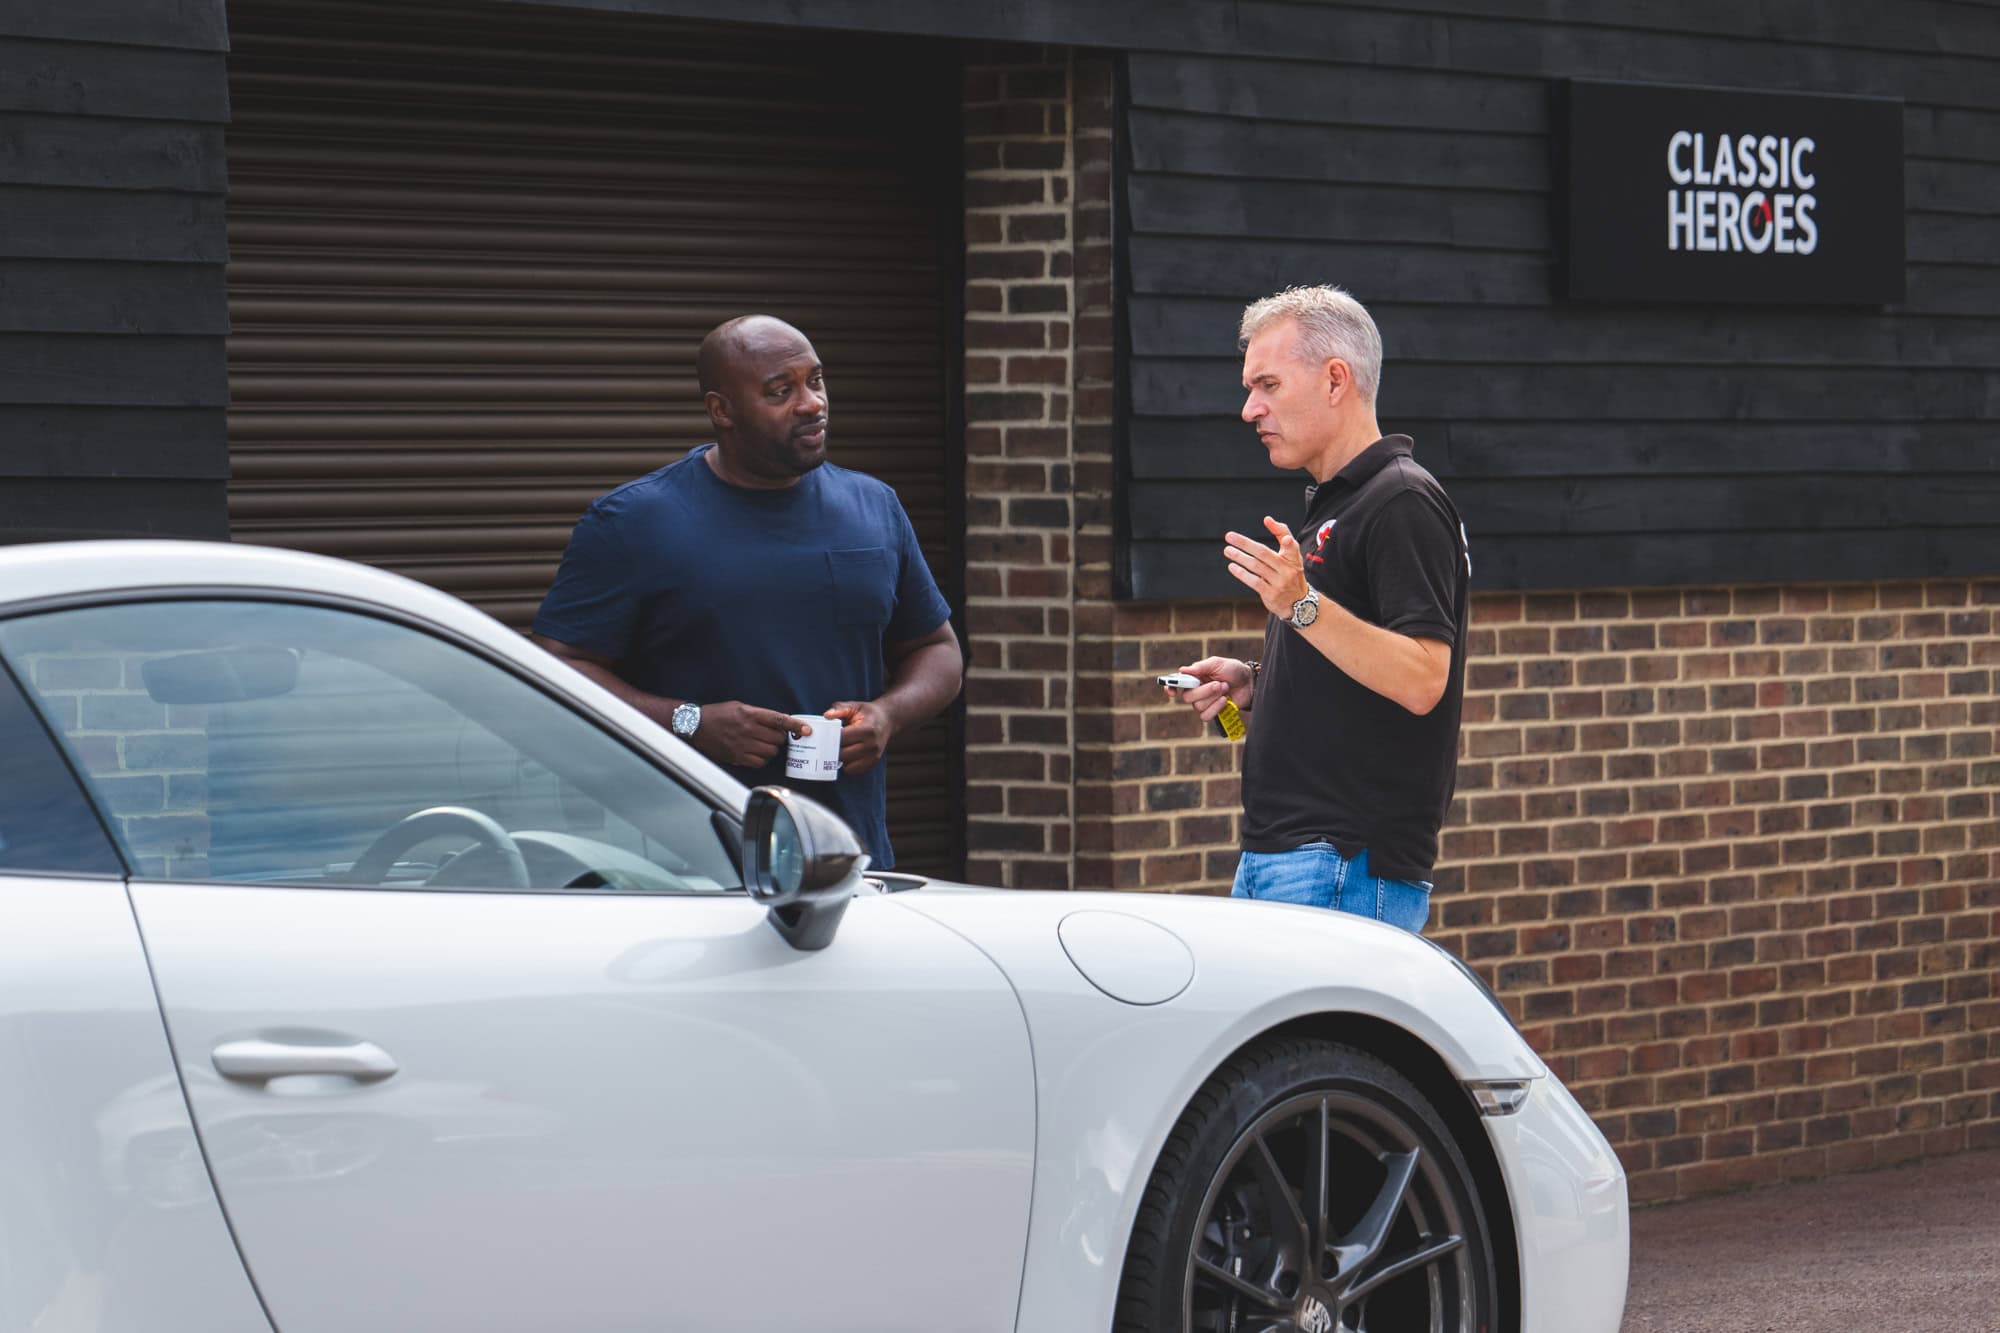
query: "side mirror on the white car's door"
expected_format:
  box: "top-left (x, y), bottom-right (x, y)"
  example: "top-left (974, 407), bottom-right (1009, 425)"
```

top-left (744, 787), bottom-right (868, 951)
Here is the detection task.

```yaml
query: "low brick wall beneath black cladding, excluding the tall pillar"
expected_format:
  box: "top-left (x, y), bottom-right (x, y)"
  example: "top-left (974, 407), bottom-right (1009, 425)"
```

top-left (1078, 580), bottom-right (2000, 1201)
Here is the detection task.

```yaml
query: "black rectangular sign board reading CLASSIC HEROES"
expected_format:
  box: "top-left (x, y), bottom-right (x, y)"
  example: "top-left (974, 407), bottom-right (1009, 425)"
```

top-left (1556, 80), bottom-right (1904, 306)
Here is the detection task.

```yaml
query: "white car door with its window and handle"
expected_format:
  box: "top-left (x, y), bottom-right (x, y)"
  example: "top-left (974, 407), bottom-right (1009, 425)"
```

top-left (0, 600), bottom-right (1034, 1333)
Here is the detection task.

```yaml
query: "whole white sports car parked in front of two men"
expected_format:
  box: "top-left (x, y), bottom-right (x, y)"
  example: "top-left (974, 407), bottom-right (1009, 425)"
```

top-left (0, 542), bottom-right (1626, 1333)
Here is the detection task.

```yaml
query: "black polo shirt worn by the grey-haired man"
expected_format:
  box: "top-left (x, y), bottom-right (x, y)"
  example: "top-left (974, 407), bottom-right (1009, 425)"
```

top-left (1242, 434), bottom-right (1470, 881)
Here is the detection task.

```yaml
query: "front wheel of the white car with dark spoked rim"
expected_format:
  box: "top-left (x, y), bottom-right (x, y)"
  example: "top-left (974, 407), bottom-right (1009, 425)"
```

top-left (1116, 1041), bottom-right (1498, 1333)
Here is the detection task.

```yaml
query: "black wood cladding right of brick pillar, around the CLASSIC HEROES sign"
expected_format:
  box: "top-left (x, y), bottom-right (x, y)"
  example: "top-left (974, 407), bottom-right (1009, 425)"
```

top-left (1120, 0), bottom-right (2000, 598)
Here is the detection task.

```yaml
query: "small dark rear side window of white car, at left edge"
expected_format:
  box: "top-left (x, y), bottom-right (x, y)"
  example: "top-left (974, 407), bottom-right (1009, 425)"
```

top-left (0, 671), bottom-right (124, 877)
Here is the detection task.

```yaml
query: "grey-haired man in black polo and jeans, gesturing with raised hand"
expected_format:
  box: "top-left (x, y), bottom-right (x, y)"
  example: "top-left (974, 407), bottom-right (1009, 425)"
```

top-left (1182, 286), bottom-right (1472, 931)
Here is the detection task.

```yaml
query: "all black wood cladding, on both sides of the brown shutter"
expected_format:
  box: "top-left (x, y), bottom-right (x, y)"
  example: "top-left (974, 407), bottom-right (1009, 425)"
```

top-left (0, 0), bottom-right (2000, 580)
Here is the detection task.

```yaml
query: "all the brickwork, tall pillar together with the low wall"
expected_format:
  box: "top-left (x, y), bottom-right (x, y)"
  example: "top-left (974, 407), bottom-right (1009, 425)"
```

top-left (966, 52), bottom-right (2000, 1201)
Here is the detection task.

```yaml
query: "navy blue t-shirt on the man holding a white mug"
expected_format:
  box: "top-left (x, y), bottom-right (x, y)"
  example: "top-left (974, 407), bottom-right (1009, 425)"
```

top-left (534, 444), bottom-right (952, 869)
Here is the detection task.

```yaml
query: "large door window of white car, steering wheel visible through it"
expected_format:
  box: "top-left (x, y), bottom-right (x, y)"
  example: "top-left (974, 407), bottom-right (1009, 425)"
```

top-left (0, 600), bottom-right (740, 893)
